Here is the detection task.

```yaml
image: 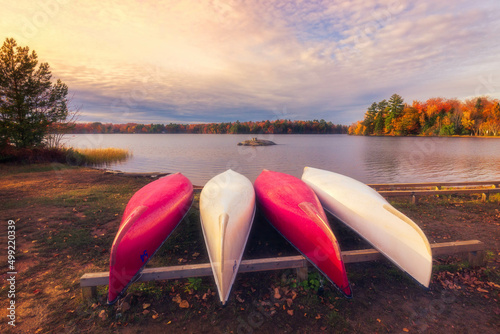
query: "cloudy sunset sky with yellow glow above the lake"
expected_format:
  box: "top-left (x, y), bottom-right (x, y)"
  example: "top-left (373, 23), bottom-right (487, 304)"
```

top-left (0, 0), bottom-right (500, 125)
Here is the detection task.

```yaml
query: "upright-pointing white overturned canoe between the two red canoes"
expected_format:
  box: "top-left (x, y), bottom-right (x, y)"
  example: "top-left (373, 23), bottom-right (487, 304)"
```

top-left (200, 169), bottom-right (255, 305)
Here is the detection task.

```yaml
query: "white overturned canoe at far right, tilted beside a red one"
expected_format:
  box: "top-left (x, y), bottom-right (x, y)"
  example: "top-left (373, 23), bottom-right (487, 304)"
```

top-left (302, 167), bottom-right (432, 287)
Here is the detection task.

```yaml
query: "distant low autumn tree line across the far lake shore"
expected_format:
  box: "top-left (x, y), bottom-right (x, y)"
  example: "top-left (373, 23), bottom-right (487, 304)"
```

top-left (71, 119), bottom-right (348, 134)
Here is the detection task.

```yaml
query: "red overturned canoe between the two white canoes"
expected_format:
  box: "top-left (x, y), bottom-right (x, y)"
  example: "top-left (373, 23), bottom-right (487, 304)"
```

top-left (254, 170), bottom-right (352, 297)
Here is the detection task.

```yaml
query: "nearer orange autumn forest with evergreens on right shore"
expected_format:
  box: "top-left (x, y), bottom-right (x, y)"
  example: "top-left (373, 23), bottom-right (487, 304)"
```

top-left (349, 94), bottom-right (500, 136)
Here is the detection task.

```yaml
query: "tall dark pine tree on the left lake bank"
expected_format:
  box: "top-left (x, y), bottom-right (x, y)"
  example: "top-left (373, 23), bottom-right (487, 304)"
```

top-left (0, 38), bottom-right (68, 148)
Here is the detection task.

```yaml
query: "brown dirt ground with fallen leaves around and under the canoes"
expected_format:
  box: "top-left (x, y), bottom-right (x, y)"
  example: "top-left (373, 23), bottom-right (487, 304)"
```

top-left (0, 164), bottom-right (500, 333)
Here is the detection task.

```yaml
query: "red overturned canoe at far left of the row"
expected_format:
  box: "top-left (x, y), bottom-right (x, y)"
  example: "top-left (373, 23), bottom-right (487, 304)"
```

top-left (108, 173), bottom-right (193, 304)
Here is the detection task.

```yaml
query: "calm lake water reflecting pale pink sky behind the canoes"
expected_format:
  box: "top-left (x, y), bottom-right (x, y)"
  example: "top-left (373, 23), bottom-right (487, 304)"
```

top-left (65, 134), bottom-right (500, 185)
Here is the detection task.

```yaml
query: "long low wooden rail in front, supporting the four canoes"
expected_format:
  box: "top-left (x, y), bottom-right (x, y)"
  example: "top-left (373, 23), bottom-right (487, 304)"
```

top-left (80, 240), bottom-right (485, 299)
